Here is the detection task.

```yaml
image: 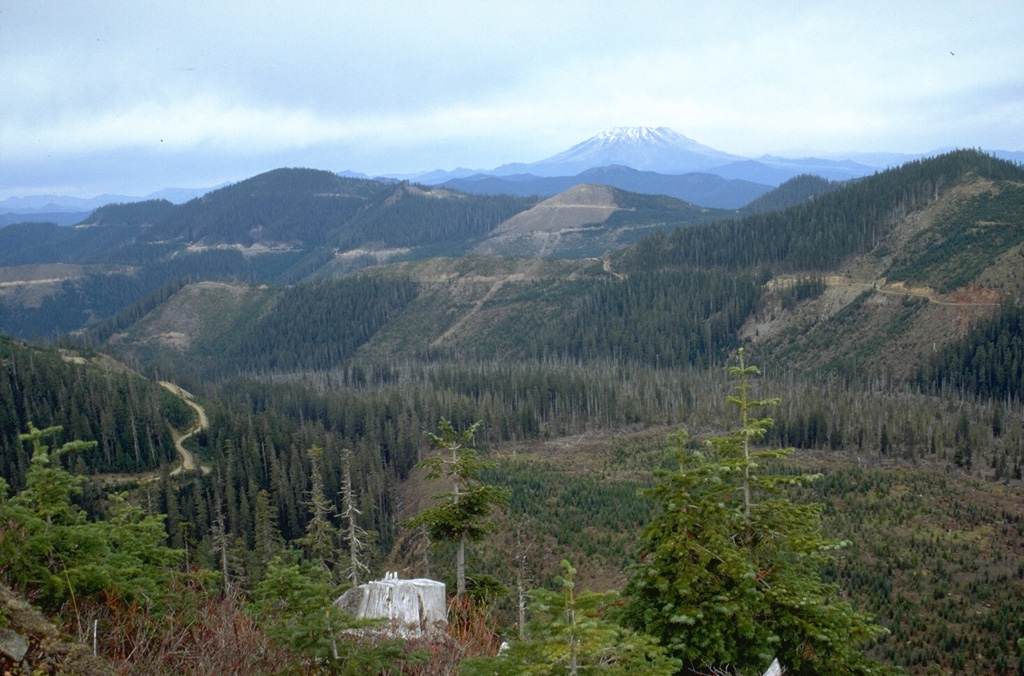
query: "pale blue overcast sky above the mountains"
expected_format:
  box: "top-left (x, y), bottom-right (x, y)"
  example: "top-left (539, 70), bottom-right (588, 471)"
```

top-left (0, 0), bottom-right (1024, 199)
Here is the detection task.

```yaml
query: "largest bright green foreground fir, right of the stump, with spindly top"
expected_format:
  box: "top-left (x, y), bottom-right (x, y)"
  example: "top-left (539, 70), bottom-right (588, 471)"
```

top-left (625, 354), bottom-right (884, 674)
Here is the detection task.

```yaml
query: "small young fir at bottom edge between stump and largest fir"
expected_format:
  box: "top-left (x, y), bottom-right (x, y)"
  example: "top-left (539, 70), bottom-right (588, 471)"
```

top-left (459, 560), bottom-right (680, 676)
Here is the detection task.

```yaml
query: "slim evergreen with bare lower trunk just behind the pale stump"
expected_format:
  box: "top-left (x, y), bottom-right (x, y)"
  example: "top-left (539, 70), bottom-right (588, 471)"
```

top-left (403, 418), bottom-right (509, 597)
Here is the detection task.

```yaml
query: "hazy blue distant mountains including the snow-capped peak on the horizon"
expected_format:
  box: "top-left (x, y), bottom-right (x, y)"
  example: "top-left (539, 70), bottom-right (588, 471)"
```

top-left (0, 127), bottom-right (1024, 226)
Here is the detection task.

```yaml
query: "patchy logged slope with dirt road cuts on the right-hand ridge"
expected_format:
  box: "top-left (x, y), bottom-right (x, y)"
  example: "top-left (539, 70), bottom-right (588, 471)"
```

top-left (743, 159), bottom-right (1024, 379)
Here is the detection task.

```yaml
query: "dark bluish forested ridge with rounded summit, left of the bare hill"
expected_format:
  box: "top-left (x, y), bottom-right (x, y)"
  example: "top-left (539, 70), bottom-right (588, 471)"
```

top-left (0, 169), bottom-right (536, 339)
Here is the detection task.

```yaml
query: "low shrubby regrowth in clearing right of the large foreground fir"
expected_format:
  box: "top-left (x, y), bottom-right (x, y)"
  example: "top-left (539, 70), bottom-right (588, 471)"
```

top-left (793, 467), bottom-right (1024, 674)
